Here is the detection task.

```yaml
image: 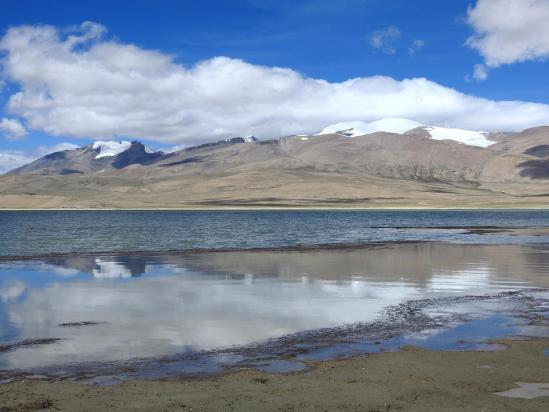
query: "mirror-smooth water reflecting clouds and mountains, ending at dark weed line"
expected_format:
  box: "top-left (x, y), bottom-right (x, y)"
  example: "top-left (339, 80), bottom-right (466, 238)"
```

top-left (0, 243), bottom-right (549, 369)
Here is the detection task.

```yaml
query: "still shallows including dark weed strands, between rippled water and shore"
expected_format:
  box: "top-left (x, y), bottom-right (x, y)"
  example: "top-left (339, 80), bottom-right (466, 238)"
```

top-left (0, 243), bottom-right (549, 383)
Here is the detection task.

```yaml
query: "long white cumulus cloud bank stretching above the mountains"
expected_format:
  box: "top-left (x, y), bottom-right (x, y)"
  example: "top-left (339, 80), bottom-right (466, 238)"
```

top-left (0, 23), bottom-right (549, 145)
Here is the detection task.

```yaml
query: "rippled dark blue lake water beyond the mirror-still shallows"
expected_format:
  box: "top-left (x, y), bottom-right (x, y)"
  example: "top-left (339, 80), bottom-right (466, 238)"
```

top-left (0, 210), bottom-right (549, 256)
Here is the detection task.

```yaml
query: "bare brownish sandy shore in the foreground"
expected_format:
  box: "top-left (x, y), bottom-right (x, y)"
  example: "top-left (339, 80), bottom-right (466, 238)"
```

top-left (0, 339), bottom-right (549, 411)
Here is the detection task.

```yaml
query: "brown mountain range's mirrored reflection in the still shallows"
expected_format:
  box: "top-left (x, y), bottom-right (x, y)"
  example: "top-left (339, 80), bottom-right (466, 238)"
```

top-left (38, 242), bottom-right (548, 286)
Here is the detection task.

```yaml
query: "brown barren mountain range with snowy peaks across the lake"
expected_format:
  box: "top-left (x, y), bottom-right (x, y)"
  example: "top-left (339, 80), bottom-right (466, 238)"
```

top-left (0, 119), bottom-right (549, 208)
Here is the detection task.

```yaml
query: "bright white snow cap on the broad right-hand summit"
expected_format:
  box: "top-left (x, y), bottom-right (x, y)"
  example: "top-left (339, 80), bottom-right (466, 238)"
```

top-left (316, 117), bottom-right (497, 147)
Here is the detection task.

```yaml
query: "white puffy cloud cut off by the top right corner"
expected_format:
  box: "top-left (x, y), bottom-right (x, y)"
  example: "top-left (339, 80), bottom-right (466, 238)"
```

top-left (467, 0), bottom-right (549, 67)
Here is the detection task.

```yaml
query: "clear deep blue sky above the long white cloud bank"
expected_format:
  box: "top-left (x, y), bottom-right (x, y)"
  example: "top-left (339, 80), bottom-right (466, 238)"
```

top-left (0, 0), bottom-right (549, 99)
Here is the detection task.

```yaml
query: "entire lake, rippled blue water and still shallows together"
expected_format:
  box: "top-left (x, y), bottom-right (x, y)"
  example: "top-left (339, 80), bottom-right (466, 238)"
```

top-left (0, 211), bottom-right (549, 383)
